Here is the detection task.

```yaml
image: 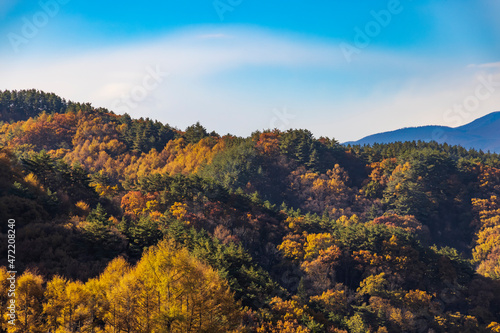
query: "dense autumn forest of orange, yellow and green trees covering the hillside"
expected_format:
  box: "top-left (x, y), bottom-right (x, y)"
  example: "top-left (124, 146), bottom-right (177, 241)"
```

top-left (0, 90), bottom-right (500, 333)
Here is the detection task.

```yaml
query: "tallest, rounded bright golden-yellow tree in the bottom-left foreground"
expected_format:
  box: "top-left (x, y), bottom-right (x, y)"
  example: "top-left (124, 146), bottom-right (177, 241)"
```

top-left (135, 241), bottom-right (240, 332)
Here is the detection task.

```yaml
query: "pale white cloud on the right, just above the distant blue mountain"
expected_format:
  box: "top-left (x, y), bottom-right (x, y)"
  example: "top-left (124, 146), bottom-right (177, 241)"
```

top-left (320, 66), bottom-right (500, 141)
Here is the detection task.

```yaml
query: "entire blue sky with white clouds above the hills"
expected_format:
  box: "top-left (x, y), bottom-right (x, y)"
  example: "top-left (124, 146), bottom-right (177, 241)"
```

top-left (0, 0), bottom-right (500, 141)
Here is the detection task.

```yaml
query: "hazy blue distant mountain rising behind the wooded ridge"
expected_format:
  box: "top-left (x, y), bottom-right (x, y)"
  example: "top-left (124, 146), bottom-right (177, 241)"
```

top-left (345, 111), bottom-right (500, 153)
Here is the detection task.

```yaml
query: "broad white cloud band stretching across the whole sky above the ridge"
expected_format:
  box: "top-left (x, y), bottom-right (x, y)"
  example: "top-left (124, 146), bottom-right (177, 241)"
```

top-left (0, 27), bottom-right (500, 141)
